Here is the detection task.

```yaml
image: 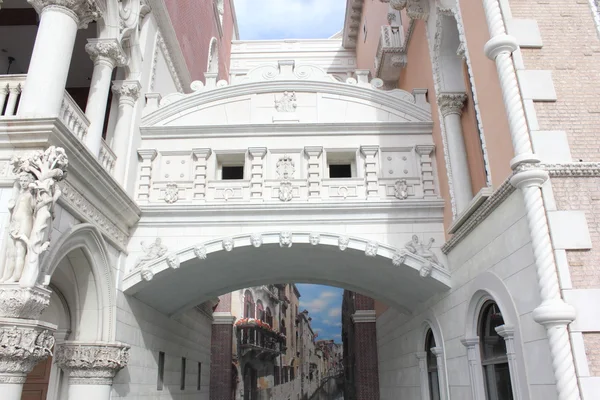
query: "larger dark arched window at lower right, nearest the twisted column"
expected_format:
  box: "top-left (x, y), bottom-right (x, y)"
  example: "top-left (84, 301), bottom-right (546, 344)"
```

top-left (478, 300), bottom-right (513, 400)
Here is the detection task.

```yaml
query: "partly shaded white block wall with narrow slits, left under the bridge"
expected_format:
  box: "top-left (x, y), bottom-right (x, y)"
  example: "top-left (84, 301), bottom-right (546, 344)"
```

top-left (112, 292), bottom-right (212, 400)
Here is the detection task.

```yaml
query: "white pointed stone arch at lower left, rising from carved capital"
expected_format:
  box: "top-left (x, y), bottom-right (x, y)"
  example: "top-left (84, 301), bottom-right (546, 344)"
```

top-left (42, 224), bottom-right (116, 342)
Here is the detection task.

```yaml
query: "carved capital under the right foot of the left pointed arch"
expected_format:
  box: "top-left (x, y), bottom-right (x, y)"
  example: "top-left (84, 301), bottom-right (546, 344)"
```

top-left (54, 342), bottom-right (130, 385)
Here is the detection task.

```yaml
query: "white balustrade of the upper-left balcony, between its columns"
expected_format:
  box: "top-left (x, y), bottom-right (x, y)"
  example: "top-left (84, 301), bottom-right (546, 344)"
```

top-left (0, 75), bottom-right (117, 174)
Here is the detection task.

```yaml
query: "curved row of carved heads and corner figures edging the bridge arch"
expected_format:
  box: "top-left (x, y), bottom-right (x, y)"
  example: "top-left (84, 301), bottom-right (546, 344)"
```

top-left (129, 231), bottom-right (443, 281)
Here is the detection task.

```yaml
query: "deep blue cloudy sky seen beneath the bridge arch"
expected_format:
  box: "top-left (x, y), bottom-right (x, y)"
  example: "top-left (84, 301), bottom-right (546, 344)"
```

top-left (296, 284), bottom-right (344, 343)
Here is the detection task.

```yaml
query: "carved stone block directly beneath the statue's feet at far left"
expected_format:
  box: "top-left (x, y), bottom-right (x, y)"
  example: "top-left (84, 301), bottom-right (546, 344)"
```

top-left (0, 284), bottom-right (52, 320)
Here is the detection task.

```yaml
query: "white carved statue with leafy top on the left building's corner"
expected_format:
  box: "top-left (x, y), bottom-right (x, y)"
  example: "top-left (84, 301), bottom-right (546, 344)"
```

top-left (0, 146), bottom-right (69, 288)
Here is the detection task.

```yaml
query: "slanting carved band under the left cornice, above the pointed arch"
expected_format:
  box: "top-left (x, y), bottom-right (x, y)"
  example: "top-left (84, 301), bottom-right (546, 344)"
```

top-left (59, 180), bottom-right (129, 248)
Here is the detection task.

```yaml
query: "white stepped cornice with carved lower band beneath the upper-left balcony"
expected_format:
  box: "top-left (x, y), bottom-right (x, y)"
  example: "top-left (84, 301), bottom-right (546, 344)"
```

top-left (0, 118), bottom-right (141, 250)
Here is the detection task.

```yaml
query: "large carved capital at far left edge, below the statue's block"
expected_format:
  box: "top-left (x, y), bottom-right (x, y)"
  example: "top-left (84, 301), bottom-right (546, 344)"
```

top-left (0, 320), bottom-right (54, 384)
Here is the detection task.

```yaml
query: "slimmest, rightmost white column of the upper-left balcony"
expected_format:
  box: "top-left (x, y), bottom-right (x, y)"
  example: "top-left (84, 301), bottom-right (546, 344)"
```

top-left (112, 80), bottom-right (142, 183)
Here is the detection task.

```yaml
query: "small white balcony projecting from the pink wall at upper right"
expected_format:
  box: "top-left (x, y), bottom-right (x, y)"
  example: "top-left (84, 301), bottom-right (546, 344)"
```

top-left (375, 25), bottom-right (407, 81)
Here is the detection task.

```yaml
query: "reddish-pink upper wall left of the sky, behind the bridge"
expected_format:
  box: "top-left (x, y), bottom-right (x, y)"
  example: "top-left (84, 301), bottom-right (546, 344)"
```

top-left (165, 0), bottom-right (234, 81)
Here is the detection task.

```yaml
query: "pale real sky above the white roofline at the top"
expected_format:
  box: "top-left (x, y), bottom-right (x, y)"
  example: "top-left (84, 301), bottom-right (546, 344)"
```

top-left (234, 0), bottom-right (346, 40)
